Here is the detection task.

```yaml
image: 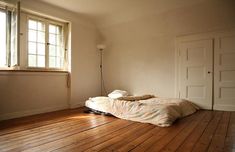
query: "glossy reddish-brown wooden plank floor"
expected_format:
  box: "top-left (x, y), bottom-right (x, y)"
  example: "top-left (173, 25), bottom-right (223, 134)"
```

top-left (0, 109), bottom-right (235, 152)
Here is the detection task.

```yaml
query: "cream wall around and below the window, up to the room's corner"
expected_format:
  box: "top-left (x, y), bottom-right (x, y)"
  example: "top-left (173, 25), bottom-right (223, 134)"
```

top-left (0, 0), bottom-right (99, 120)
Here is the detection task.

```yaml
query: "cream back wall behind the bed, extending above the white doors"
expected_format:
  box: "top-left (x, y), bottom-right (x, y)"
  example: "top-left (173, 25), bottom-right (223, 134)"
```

top-left (100, 0), bottom-right (235, 97)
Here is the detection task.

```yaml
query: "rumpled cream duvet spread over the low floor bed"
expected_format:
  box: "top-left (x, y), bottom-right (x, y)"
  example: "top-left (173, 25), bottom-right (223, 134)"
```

top-left (86, 97), bottom-right (198, 127)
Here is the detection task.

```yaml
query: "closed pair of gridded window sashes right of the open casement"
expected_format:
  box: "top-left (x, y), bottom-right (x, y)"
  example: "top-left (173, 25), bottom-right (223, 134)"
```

top-left (27, 17), bottom-right (65, 69)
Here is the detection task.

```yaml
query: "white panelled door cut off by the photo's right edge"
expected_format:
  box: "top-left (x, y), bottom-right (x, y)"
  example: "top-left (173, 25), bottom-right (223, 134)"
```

top-left (214, 31), bottom-right (235, 111)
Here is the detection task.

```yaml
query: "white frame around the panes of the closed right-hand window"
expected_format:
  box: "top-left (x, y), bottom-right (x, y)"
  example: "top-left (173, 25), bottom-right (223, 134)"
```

top-left (25, 14), bottom-right (68, 71)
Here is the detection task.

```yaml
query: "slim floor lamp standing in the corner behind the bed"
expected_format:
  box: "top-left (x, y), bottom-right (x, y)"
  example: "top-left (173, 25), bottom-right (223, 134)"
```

top-left (97, 44), bottom-right (106, 96)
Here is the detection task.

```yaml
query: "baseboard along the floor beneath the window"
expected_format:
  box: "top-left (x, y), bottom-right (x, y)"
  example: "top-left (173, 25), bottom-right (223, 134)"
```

top-left (0, 105), bottom-right (69, 120)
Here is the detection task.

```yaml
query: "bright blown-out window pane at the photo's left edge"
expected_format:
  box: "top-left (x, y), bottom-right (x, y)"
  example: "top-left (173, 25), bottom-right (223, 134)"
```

top-left (0, 12), bottom-right (6, 66)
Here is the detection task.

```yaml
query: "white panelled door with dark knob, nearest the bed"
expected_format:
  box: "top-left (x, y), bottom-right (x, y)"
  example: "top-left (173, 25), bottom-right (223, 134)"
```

top-left (178, 39), bottom-right (213, 109)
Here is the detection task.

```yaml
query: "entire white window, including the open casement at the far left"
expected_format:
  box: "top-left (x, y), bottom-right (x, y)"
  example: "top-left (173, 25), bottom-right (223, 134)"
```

top-left (0, 2), bottom-right (69, 71)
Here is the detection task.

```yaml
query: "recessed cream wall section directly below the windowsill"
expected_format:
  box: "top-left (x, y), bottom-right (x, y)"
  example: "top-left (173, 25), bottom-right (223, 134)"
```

top-left (0, 72), bottom-right (68, 119)
